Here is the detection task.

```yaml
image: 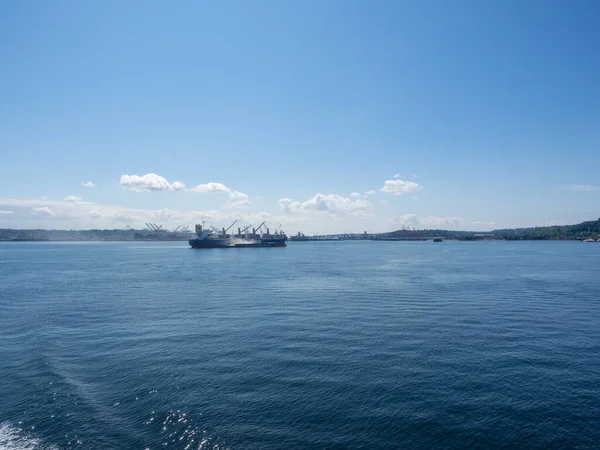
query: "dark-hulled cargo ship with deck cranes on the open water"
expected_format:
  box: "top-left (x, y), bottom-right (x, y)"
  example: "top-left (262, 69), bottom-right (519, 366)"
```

top-left (189, 220), bottom-right (287, 248)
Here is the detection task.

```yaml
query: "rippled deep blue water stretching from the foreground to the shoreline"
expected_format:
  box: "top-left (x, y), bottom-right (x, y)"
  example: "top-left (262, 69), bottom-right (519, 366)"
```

top-left (0, 242), bottom-right (600, 449)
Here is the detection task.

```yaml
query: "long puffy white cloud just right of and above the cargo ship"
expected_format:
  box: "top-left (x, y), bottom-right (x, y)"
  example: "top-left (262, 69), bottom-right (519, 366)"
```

top-left (278, 194), bottom-right (373, 215)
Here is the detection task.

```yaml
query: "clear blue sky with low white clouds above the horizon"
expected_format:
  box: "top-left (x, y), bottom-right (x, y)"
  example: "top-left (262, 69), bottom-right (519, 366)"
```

top-left (0, 0), bottom-right (600, 234)
